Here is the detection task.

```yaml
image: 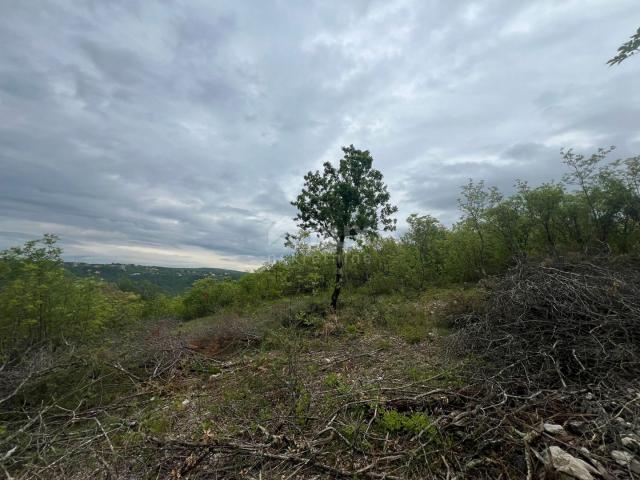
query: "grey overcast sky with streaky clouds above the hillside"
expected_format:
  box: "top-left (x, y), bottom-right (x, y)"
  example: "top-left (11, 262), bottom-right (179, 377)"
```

top-left (0, 0), bottom-right (640, 269)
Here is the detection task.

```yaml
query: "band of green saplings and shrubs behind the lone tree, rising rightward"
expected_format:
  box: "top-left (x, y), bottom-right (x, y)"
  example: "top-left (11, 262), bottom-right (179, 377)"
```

top-left (179, 148), bottom-right (640, 318)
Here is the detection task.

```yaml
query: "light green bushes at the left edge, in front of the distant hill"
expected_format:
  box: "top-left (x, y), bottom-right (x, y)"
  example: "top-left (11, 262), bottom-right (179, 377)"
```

top-left (0, 235), bottom-right (177, 358)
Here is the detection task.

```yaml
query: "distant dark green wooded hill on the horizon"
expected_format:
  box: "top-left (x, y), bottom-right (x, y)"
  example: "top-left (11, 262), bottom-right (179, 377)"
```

top-left (64, 262), bottom-right (245, 295)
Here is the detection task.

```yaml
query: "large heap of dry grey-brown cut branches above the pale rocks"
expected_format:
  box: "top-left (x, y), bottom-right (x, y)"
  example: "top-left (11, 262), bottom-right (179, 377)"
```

top-left (456, 261), bottom-right (640, 389)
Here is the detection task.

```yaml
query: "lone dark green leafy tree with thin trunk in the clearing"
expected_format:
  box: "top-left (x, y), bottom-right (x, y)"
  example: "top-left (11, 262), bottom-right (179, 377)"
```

top-left (291, 145), bottom-right (398, 310)
